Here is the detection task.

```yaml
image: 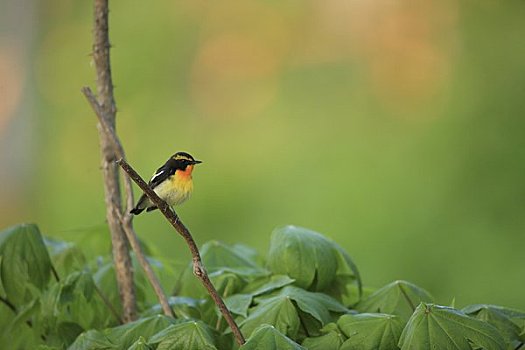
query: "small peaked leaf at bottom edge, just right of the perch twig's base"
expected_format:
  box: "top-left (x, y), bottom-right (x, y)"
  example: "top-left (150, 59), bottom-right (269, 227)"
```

top-left (239, 324), bottom-right (305, 350)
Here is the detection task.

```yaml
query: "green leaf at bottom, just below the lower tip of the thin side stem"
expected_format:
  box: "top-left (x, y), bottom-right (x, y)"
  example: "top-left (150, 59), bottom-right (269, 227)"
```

top-left (104, 315), bottom-right (175, 349)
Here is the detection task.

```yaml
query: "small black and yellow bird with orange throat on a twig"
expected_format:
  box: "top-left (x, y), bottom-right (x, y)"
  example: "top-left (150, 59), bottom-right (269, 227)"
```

top-left (130, 152), bottom-right (202, 215)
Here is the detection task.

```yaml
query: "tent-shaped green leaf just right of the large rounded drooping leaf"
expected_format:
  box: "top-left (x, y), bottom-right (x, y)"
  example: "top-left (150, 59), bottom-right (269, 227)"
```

top-left (355, 281), bottom-right (432, 321)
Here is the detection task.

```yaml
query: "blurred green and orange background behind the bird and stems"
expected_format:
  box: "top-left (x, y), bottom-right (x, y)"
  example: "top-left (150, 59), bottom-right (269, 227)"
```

top-left (0, 0), bottom-right (525, 309)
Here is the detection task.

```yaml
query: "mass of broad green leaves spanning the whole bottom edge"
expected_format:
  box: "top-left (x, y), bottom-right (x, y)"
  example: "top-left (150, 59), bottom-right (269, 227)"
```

top-left (0, 225), bottom-right (525, 350)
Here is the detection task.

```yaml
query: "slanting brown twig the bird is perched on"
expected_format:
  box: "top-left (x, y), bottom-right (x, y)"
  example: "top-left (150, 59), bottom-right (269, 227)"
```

top-left (117, 159), bottom-right (245, 345)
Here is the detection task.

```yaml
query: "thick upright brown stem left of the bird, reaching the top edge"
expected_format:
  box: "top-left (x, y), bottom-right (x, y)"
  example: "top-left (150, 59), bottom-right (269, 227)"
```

top-left (90, 0), bottom-right (137, 322)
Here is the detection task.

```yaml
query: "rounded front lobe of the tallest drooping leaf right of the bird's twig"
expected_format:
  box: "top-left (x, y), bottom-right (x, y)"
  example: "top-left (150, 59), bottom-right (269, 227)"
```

top-left (268, 226), bottom-right (337, 291)
